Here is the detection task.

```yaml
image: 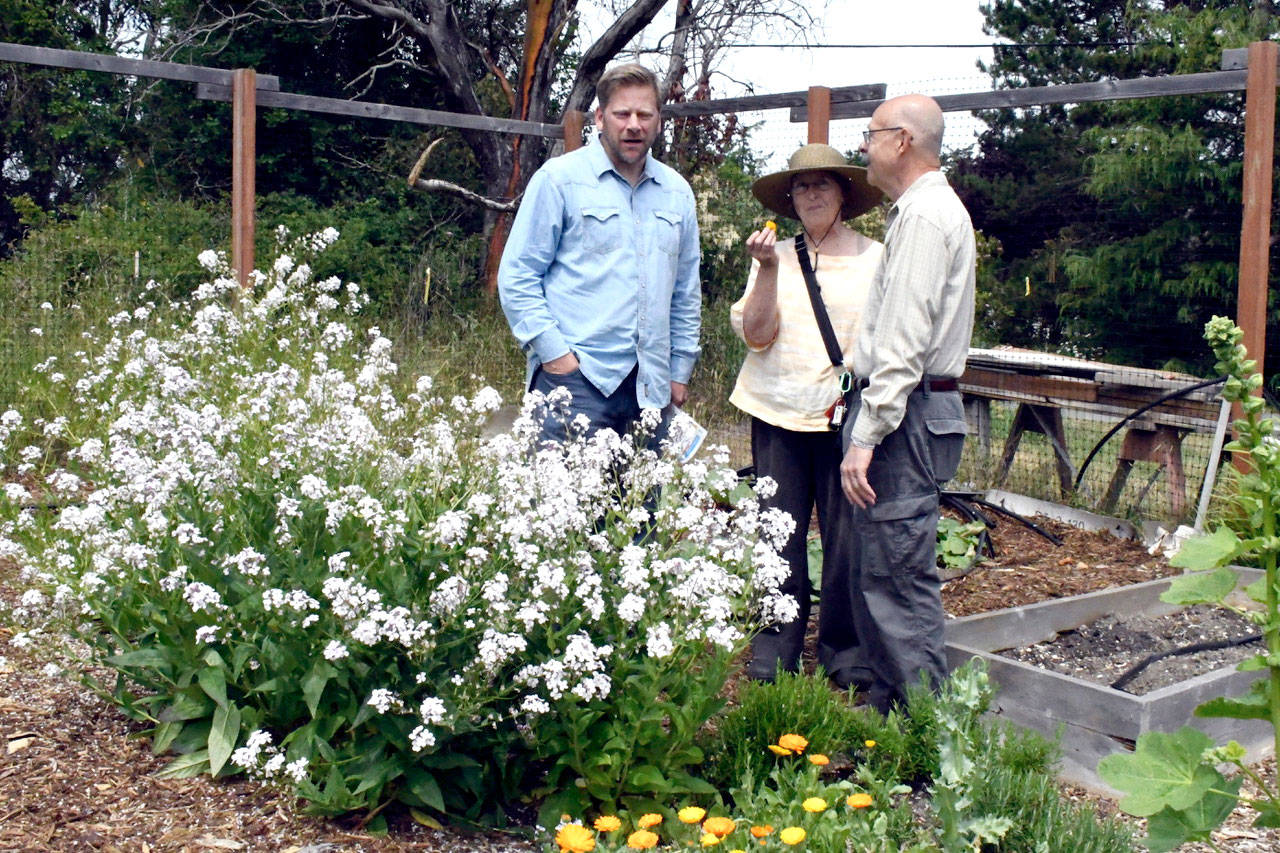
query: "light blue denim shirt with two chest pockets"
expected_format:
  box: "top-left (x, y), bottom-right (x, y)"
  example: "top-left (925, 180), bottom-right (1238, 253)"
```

top-left (498, 138), bottom-right (701, 407)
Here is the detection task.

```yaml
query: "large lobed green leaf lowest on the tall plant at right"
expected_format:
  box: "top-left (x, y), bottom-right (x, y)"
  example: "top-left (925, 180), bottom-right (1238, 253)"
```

top-left (1098, 726), bottom-right (1225, 817)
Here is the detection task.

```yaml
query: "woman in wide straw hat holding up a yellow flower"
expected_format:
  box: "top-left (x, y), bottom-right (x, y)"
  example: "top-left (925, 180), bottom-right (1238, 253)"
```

top-left (730, 143), bottom-right (884, 686)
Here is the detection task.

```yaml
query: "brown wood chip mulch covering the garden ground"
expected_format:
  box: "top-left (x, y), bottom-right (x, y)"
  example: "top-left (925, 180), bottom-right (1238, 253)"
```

top-left (0, 519), bottom-right (1280, 853)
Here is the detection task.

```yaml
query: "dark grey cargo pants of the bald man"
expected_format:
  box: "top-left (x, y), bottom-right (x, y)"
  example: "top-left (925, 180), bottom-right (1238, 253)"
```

top-left (845, 388), bottom-right (965, 712)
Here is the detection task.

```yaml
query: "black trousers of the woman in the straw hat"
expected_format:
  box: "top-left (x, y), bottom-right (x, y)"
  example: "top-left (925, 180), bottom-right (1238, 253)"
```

top-left (748, 418), bottom-right (858, 678)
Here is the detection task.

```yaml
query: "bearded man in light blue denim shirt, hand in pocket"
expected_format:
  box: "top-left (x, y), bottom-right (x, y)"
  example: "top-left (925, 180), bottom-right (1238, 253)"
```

top-left (498, 64), bottom-right (701, 439)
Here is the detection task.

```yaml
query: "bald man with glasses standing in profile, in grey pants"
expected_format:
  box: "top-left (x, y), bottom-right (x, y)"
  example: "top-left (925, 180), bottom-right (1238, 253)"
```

top-left (833, 95), bottom-right (977, 712)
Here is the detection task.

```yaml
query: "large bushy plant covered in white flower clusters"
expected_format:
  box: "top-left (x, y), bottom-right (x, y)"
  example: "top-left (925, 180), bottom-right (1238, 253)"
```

top-left (0, 231), bottom-right (795, 820)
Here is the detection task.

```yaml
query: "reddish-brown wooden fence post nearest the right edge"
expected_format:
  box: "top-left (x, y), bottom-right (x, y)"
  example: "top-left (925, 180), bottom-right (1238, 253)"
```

top-left (1234, 41), bottom-right (1277, 471)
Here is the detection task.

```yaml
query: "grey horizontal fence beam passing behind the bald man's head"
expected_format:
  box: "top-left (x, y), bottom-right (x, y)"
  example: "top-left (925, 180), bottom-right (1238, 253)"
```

top-left (791, 70), bottom-right (1247, 122)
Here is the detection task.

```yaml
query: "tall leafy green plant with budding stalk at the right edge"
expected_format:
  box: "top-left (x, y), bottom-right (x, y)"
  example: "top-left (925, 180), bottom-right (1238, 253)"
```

top-left (1098, 316), bottom-right (1280, 850)
